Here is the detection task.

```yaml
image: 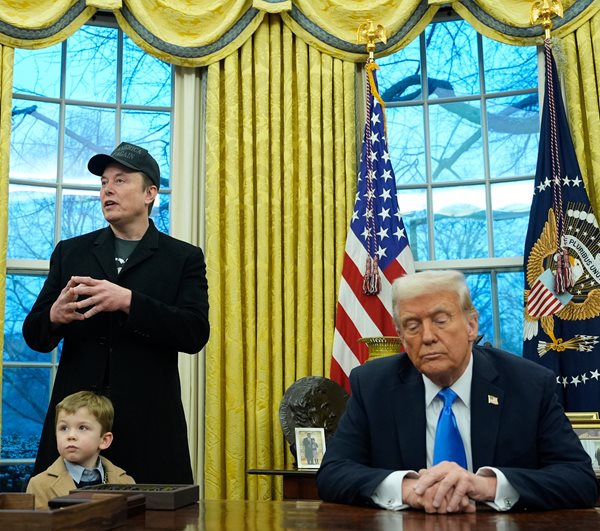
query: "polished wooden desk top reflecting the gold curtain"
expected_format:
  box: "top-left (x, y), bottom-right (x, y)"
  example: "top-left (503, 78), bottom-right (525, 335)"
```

top-left (119, 500), bottom-right (600, 531)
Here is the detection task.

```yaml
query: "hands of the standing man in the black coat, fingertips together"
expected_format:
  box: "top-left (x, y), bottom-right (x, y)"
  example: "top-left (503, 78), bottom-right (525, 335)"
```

top-left (50, 277), bottom-right (131, 325)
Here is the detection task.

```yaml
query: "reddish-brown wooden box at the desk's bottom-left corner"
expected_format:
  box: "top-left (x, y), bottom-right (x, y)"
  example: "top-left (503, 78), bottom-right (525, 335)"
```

top-left (0, 493), bottom-right (127, 531)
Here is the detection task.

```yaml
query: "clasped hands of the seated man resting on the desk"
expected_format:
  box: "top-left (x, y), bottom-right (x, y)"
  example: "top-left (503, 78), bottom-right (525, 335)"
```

top-left (402, 461), bottom-right (496, 513)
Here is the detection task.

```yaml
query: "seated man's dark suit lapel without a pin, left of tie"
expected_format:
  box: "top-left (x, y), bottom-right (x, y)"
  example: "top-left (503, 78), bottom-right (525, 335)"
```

top-left (391, 355), bottom-right (427, 470)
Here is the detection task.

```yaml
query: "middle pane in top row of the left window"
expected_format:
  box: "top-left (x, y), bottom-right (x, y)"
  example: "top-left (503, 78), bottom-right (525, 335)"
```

top-left (65, 26), bottom-right (119, 103)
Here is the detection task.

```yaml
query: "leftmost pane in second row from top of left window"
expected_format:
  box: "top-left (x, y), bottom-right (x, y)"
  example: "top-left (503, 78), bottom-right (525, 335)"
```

top-left (10, 98), bottom-right (60, 182)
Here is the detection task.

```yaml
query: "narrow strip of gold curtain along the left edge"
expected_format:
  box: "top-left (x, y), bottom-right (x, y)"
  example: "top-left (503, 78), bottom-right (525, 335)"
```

top-left (0, 45), bottom-right (14, 446)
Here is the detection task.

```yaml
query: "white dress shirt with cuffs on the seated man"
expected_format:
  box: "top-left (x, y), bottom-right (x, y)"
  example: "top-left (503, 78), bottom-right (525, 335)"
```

top-left (371, 354), bottom-right (519, 511)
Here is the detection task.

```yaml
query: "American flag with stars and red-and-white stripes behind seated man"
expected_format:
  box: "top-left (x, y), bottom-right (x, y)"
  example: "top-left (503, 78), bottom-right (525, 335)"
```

top-left (330, 60), bottom-right (414, 392)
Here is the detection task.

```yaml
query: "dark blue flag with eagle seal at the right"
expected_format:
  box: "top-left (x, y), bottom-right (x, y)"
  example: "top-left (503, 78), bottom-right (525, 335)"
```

top-left (523, 39), bottom-right (600, 411)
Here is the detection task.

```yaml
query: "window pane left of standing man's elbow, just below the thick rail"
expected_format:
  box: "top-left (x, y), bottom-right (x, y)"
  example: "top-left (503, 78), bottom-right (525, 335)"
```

top-left (3, 275), bottom-right (49, 363)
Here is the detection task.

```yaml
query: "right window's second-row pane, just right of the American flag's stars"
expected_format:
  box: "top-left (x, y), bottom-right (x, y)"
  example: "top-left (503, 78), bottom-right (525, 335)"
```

top-left (386, 106), bottom-right (427, 185)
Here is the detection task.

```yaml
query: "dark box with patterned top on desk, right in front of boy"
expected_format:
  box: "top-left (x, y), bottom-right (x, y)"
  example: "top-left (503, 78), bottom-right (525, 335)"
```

top-left (71, 483), bottom-right (200, 511)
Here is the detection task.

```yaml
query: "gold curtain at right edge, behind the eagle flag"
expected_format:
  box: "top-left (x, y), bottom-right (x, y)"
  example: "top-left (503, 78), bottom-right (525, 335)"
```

top-left (557, 9), bottom-right (600, 216)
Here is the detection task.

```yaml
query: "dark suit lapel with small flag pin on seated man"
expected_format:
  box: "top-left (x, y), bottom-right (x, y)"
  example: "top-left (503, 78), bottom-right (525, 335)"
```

top-left (471, 347), bottom-right (504, 471)
